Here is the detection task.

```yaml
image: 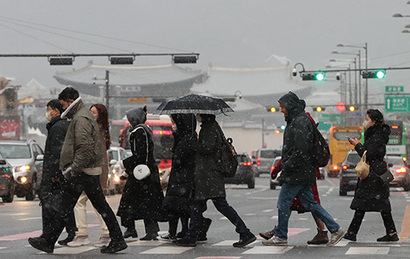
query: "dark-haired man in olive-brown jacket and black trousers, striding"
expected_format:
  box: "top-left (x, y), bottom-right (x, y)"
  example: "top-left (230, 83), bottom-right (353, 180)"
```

top-left (28, 87), bottom-right (127, 253)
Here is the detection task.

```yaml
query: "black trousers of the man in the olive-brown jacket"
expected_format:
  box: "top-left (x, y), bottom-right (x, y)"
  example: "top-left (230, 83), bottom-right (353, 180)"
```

top-left (43, 173), bottom-right (124, 245)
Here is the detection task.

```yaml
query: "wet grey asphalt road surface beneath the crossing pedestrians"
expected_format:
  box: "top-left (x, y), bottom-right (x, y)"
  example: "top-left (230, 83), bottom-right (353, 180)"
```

top-left (0, 176), bottom-right (410, 259)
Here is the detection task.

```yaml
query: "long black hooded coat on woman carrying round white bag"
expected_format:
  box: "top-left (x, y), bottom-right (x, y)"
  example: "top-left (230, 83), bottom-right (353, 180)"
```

top-left (117, 107), bottom-right (167, 221)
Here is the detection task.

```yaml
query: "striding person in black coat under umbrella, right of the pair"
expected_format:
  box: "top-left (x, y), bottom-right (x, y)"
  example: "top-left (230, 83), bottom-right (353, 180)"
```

top-left (176, 114), bottom-right (256, 247)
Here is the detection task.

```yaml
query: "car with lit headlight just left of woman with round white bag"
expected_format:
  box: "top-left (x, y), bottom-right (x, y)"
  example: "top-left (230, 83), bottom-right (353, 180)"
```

top-left (107, 147), bottom-right (128, 195)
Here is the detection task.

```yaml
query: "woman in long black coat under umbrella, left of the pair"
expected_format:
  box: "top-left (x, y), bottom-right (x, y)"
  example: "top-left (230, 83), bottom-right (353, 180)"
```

top-left (163, 114), bottom-right (197, 239)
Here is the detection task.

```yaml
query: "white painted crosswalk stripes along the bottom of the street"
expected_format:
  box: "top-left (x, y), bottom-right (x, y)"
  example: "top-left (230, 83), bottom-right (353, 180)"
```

top-left (16, 237), bottom-right (410, 259)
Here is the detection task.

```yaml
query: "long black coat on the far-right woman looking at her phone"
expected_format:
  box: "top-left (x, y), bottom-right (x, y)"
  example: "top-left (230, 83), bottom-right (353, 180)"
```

top-left (350, 124), bottom-right (391, 212)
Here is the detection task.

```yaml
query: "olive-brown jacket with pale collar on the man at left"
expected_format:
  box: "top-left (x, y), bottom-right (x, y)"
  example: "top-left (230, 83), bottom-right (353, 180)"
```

top-left (60, 97), bottom-right (104, 175)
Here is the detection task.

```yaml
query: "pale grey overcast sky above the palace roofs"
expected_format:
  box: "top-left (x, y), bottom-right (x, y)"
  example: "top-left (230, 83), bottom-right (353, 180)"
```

top-left (0, 0), bottom-right (410, 101)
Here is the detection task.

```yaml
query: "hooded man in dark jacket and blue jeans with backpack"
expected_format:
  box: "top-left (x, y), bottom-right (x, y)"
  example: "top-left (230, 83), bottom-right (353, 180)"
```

top-left (262, 92), bottom-right (346, 246)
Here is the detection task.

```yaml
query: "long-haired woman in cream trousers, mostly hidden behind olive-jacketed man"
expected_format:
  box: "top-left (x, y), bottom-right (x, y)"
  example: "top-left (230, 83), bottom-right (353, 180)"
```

top-left (67, 103), bottom-right (111, 247)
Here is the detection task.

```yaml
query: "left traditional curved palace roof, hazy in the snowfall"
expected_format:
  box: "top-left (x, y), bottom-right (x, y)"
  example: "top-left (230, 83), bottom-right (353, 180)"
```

top-left (54, 64), bottom-right (207, 97)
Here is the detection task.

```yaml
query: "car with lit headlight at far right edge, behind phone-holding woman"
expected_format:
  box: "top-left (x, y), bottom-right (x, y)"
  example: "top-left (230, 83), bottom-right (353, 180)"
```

top-left (385, 156), bottom-right (410, 192)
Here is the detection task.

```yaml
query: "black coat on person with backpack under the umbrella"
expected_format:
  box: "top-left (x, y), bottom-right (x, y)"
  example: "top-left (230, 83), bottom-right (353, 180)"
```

top-left (194, 117), bottom-right (226, 200)
